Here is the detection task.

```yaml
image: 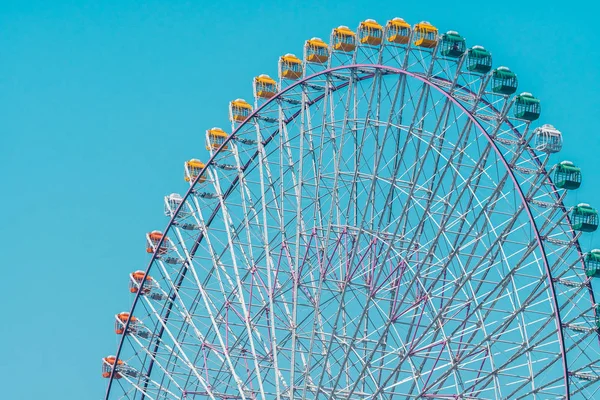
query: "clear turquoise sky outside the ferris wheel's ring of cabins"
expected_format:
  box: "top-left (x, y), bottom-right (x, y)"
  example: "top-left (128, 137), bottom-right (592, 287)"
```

top-left (0, 0), bottom-right (600, 400)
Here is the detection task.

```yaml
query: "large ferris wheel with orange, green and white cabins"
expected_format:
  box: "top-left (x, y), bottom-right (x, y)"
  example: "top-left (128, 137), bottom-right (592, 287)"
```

top-left (102, 18), bottom-right (600, 400)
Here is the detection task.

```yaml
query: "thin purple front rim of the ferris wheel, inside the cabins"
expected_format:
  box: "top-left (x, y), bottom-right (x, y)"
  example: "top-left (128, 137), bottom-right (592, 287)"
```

top-left (105, 64), bottom-right (581, 400)
